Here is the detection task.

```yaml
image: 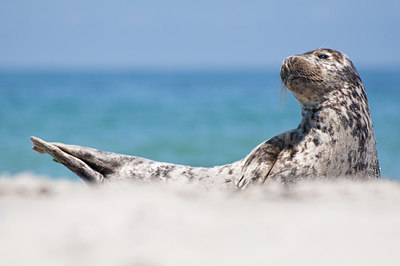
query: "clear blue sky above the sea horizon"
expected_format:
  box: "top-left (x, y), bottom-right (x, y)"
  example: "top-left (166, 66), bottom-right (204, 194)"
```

top-left (0, 0), bottom-right (400, 69)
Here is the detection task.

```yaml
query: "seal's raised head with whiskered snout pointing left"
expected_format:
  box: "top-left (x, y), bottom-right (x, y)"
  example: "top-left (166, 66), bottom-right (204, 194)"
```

top-left (281, 49), bottom-right (361, 106)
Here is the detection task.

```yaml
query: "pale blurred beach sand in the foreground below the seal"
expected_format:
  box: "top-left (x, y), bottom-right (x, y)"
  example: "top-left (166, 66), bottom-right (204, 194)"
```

top-left (0, 174), bottom-right (400, 266)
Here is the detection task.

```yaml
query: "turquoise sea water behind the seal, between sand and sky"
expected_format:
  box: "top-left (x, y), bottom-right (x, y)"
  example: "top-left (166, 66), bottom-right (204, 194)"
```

top-left (0, 69), bottom-right (400, 180)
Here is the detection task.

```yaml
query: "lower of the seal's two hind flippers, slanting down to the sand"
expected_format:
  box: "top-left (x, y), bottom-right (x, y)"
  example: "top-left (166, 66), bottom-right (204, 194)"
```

top-left (31, 137), bottom-right (104, 183)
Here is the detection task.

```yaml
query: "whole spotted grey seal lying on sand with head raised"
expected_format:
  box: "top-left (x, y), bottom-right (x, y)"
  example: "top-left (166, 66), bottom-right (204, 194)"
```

top-left (31, 49), bottom-right (380, 189)
